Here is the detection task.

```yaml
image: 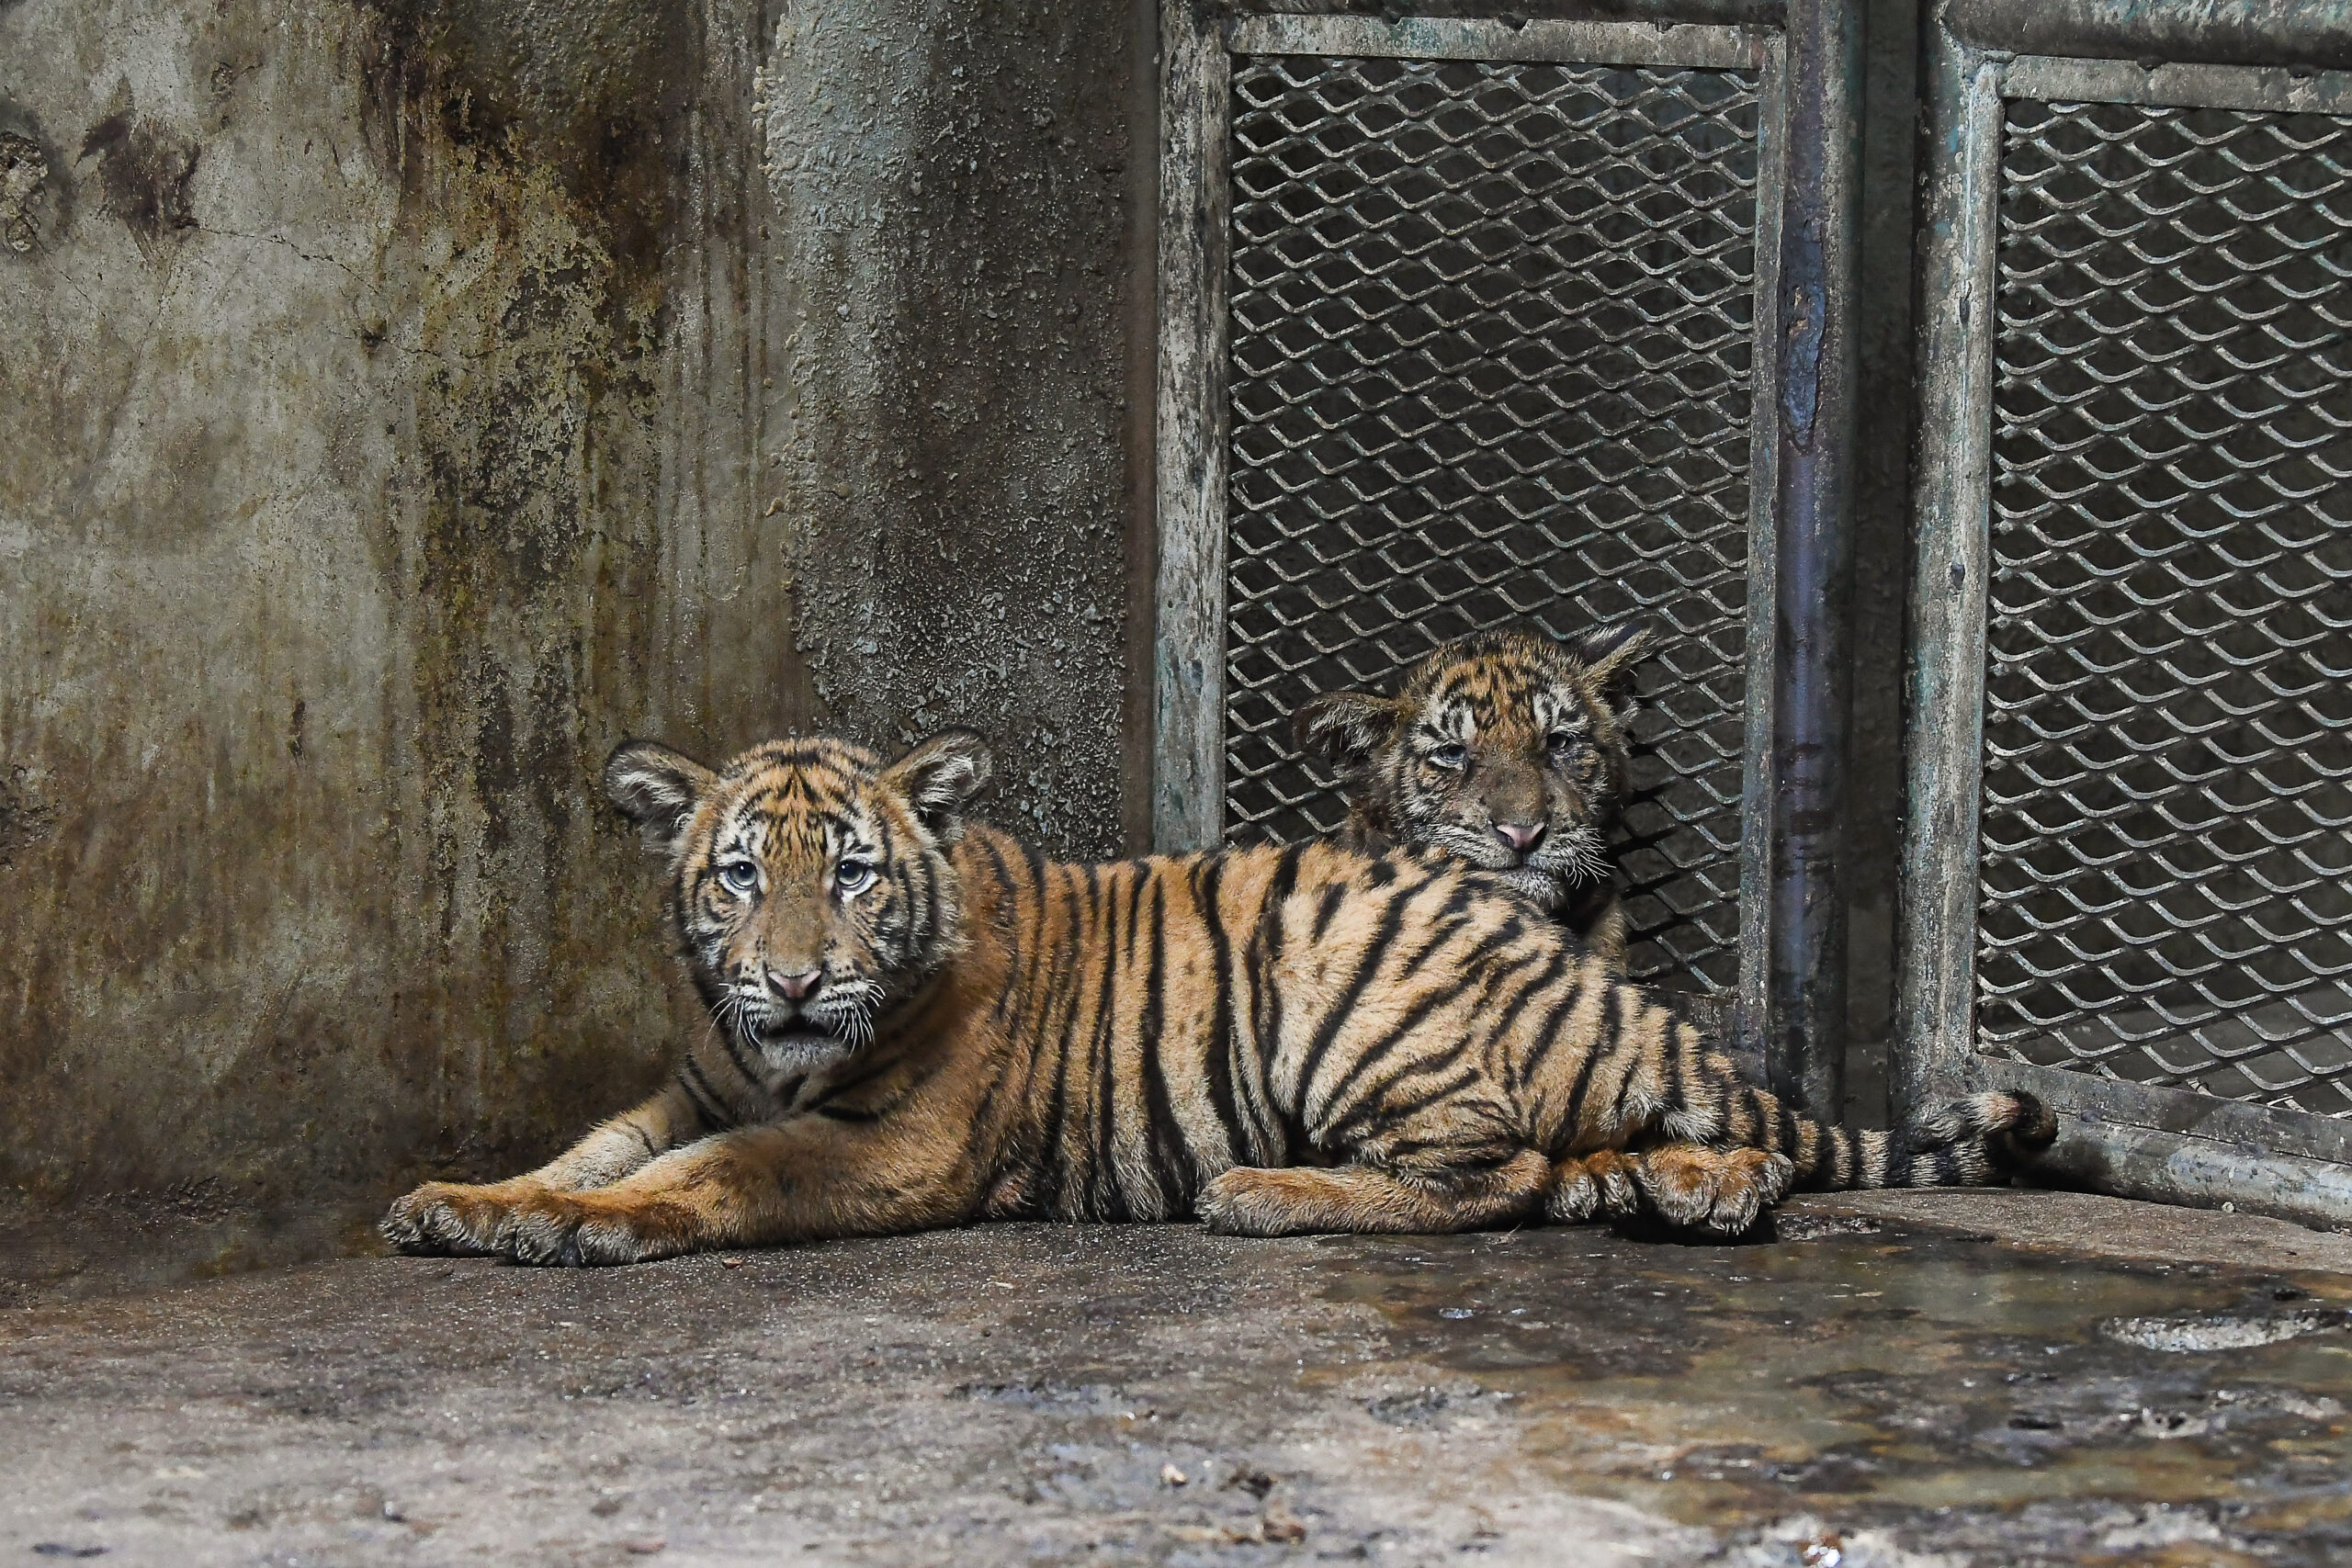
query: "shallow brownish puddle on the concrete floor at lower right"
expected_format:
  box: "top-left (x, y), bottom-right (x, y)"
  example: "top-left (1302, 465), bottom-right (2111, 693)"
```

top-left (1324, 1224), bottom-right (2352, 1561)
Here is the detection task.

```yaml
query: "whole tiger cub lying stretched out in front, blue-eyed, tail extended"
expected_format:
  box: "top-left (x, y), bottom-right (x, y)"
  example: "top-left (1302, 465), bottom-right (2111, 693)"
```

top-left (383, 731), bottom-right (2053, 1262)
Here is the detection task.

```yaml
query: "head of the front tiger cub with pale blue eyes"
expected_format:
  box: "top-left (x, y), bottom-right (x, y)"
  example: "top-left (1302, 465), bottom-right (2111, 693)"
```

top-left (605, 728), bottom-right (990, 1075)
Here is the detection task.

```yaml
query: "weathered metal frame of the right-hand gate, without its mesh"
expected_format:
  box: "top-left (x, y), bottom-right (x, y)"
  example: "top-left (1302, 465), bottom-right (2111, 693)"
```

top-left (1891, 0), bottom-right (2352, 1223)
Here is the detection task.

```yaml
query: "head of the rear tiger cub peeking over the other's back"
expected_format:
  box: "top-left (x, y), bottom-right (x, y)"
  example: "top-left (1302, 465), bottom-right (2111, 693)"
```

top-left (1294, 626), bottom-right (1649, 909)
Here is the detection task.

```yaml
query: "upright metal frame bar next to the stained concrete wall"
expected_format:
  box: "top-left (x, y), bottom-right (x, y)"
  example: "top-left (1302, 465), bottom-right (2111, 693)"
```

top-left (1152, 0), bottom-right (1230, 851)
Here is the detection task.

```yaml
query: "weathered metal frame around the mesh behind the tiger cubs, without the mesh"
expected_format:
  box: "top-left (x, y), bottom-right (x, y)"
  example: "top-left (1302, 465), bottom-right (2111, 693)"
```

top-left (1150, 0), bottom-right (1860, 1119)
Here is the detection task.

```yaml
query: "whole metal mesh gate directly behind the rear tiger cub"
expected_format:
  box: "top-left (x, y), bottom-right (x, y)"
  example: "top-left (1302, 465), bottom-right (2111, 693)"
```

top-left (1152, 5), bottom-right (1851, 1114)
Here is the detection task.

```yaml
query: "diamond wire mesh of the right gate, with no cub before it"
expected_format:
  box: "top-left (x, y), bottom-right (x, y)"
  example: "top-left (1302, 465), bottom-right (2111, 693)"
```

top-left (1978, 101), bottom-right (2352, 1117)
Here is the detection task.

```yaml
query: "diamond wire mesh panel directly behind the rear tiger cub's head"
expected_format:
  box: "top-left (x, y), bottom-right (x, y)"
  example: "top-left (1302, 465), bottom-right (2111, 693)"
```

top-left (1226, 56), bottom-right (1759, 989)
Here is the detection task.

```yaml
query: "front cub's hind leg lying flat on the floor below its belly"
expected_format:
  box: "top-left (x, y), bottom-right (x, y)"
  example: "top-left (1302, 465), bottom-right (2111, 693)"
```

top-left (1197, 1149), bottom-right (1553, 1236)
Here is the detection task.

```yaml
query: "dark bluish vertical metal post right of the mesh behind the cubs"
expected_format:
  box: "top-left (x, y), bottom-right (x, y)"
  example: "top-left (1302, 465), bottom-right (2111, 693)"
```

top-left (1764, 0), bottom-right (1863, 1122)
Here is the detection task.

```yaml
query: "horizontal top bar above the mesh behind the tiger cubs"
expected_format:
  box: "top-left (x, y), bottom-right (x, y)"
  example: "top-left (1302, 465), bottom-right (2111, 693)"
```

top-left (1226, 17), bottom-right (1773, 71)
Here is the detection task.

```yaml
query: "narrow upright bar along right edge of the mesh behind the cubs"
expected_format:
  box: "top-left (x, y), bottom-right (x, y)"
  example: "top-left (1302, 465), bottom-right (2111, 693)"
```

top-left (1722, 38), bottom-right (1788, 1079)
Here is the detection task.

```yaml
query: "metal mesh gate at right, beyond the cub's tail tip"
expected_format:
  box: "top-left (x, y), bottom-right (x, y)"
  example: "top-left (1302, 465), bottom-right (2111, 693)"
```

top-left (1898, 0), bottom-right (2352, 1220)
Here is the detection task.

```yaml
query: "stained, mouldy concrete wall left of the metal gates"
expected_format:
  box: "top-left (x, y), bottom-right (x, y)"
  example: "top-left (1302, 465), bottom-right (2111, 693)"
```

top-left (0, 0), bottom-right (1148, 1199)
